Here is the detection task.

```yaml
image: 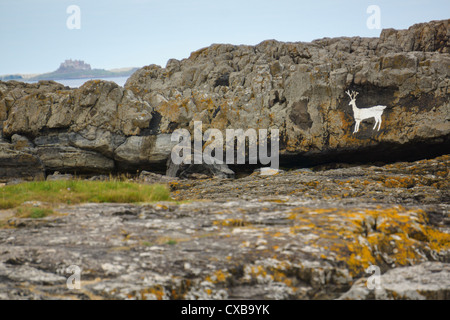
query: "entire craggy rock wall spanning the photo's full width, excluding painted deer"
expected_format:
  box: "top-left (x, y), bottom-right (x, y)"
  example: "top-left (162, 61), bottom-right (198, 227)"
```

top-left (0, 20), bottom-right (450, 179)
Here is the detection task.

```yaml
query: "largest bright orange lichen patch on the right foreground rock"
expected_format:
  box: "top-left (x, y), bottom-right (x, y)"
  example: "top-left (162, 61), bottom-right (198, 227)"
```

top-left (288, 206), bottom-right (450, 276)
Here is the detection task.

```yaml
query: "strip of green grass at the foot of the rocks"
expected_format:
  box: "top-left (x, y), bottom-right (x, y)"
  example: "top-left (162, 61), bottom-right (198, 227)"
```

top-left (0, 180), bottom-right (170, 209)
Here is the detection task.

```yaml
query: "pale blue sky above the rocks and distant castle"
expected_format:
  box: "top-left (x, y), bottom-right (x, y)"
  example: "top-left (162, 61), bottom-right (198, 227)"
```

top-left (0, 0), bottom-right (450, 75)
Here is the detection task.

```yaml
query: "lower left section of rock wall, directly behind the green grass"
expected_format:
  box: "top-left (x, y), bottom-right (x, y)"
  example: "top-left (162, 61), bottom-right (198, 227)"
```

top-left (0, 81), bottom-right (171, 173)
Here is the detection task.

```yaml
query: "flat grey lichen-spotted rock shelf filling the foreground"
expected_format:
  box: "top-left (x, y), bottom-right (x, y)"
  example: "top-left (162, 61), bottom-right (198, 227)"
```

top-left (0, 155), bottom-right (450, 299)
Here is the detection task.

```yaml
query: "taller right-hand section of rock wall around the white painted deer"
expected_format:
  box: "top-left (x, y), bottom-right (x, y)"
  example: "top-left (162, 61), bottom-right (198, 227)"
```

top-left (125, 20), bottom-right (450, 163)
